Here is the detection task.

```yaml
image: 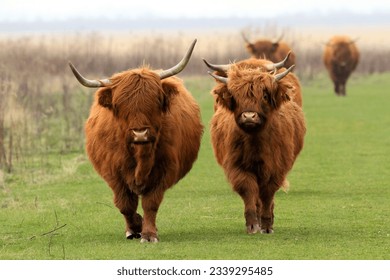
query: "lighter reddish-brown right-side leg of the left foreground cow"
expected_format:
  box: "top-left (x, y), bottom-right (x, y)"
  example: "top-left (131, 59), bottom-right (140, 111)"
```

top-left (141, 190), bottom-right (164, 242)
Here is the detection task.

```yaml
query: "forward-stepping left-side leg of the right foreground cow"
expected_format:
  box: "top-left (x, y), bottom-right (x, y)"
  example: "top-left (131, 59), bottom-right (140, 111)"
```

top-left (228, 170), bottom-right (260, 234)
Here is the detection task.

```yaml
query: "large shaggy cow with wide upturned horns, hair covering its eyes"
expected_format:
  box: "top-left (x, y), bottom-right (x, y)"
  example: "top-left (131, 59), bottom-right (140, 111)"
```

top-left (70, 40), bottom-right (203, 242)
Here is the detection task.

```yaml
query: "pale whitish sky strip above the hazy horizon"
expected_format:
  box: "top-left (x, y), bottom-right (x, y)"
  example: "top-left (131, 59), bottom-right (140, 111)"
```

top-left (0, 0), bottom-right (390, 22)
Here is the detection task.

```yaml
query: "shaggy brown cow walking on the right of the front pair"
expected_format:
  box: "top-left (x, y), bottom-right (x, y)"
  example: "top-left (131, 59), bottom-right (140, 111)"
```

top-left (203, 54), bottom-right (306, 234)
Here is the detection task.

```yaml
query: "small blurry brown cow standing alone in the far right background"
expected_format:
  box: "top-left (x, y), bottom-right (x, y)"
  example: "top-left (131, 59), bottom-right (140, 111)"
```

top-left (323, 36), bottom-right (359, 96)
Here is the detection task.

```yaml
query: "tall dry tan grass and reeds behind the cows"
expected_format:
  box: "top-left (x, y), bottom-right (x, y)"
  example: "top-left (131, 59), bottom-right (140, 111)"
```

top-left (0, 26), bottom-right (390, 172)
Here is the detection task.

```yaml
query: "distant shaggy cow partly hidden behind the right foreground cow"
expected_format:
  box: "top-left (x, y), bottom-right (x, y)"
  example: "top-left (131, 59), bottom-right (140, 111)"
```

top-left (242, 33), bottom-right (295, 68)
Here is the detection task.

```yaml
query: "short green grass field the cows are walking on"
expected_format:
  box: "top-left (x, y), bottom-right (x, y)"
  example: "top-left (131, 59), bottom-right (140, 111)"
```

top-left (0, 74), bottom-right (390, 260)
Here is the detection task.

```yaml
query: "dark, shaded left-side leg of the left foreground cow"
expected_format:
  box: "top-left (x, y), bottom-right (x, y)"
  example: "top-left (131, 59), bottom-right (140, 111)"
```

top-left (114, 187), bottom-right (142, 239)
